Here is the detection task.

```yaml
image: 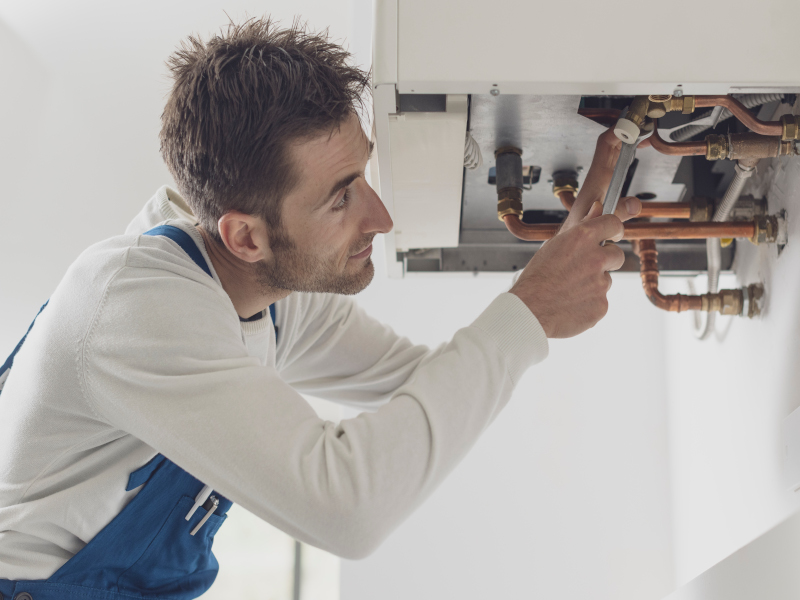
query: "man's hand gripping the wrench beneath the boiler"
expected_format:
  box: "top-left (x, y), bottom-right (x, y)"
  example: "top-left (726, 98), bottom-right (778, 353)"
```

top-left (510, 130), bottom-right (642, 338)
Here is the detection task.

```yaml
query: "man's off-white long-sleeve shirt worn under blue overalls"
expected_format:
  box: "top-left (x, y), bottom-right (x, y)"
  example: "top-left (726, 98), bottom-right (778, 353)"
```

top-left (0, 188), bottom-right (547, 579)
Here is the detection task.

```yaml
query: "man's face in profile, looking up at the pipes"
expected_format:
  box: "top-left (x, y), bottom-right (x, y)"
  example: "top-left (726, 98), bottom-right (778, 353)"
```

top-left (256, 116), bottom-right (392, 294)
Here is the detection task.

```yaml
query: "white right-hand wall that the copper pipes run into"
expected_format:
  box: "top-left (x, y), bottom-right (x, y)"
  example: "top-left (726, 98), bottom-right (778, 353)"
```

top-left (666, 135), bottom-right (800, 584)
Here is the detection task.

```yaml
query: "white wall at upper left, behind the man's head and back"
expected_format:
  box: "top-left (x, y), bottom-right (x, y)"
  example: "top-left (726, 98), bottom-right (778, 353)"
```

top-left (0, 0), bottom-right (357, 348)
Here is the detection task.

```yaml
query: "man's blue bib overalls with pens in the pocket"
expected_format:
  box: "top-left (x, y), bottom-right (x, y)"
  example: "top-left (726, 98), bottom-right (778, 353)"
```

top-left (0, 225), bottom-right (275, 600)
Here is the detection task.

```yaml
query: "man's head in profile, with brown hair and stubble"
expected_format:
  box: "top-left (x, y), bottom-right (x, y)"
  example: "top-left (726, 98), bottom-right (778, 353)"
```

top-left (161, 20), bottom-right (391, 293)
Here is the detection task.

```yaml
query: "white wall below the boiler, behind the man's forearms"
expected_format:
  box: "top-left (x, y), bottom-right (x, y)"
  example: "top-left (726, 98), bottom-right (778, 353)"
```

top-left (341, 264), bottom-right (673, 600)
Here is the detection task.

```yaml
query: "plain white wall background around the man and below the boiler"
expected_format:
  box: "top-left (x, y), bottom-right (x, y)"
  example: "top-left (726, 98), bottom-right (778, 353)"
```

top-left (0, 0), bottom-right (800, 600)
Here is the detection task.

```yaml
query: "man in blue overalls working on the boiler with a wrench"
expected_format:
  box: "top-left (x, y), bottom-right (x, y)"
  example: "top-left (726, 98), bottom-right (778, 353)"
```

top-left (0, 20), bottom-right (640, 600)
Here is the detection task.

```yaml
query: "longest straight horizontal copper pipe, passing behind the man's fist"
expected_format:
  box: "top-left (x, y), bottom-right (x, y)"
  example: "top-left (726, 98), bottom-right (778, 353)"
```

top-left (503, 215), bottom-right (757, 242)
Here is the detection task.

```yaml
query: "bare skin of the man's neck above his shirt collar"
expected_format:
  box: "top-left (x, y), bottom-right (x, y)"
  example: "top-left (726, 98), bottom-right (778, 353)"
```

top-left (197, 226), bottom-right (292, 319)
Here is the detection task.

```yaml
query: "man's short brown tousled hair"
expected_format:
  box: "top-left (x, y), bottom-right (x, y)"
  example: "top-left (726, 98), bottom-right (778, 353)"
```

top-left (160, 18), bottom-right (370, 241)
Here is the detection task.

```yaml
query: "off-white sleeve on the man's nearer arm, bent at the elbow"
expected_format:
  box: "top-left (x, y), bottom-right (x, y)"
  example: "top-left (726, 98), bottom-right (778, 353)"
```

top-left (79, 267), bottom-right (547, 558)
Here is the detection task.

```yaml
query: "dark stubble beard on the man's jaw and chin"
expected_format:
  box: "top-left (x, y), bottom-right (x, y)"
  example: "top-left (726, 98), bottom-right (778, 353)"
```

top-left (255, 226), bottom-right (375, 296)
